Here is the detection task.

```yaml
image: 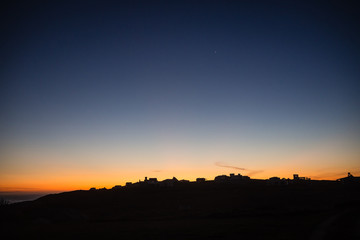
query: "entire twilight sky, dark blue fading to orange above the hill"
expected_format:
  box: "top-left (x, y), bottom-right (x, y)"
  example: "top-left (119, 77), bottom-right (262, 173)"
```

top-left (0, 1), bottom-right (360, 192)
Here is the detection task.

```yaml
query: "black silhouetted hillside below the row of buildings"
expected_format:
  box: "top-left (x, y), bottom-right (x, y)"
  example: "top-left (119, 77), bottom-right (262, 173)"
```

top-left (0, 181), bottom-right (360, 240)
